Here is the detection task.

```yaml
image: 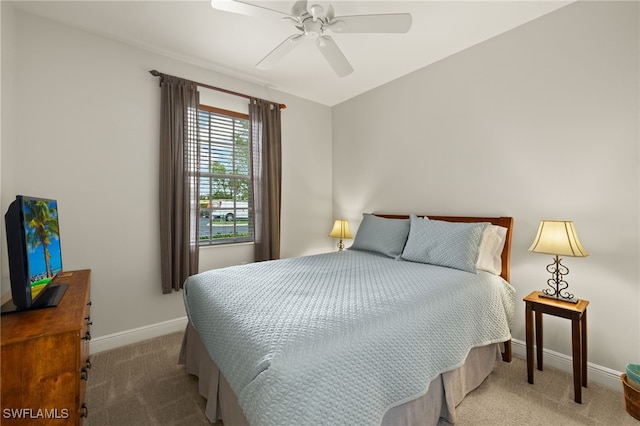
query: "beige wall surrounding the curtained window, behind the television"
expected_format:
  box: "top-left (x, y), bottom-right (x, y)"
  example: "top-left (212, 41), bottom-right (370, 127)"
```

top-left (0, 6), bottom-right (334, 338)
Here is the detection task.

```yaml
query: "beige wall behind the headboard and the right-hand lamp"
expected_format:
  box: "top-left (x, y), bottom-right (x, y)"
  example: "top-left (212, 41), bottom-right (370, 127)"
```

top-left (333, 1), bottom-right (640, 371)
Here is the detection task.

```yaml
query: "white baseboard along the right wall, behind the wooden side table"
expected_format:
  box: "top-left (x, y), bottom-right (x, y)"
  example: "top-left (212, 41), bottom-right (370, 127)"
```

top-left (511, 339), bottom-right (622, 392)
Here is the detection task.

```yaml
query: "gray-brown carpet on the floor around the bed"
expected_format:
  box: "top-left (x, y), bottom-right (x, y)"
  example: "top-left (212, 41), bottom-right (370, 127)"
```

top-left (84, 333), bottom-right (640, 426)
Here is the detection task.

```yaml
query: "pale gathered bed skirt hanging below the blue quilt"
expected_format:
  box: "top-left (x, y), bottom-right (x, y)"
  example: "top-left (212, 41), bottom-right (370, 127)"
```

top-left (178, 324), bottom-right (500, 426)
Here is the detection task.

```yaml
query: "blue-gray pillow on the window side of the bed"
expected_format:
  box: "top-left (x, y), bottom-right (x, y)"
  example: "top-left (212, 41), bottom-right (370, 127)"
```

top-left (349, 213), bottom-right (409, 258)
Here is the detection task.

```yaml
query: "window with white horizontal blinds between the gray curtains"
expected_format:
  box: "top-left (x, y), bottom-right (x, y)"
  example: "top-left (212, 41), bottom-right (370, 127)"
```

top-left (198, 105), bottom-right (253, 246)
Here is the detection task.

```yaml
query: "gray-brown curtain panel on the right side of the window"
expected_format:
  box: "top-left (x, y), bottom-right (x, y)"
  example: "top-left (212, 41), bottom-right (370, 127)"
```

top-left (249, 99), bottom-right (282, 262)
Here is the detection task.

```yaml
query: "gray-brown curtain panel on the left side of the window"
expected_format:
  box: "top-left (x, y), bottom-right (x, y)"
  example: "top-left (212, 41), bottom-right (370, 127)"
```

top-left (159, 76), bottom-right (200, 294)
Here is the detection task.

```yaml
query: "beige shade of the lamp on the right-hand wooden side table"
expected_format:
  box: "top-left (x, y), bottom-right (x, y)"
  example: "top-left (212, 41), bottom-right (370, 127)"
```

top-left (529, 220), bottom-right (589, 257)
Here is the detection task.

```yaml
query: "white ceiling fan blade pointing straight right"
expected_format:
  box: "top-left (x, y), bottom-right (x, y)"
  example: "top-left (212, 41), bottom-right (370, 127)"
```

top-left (325, 13), bottom-right (411, 33)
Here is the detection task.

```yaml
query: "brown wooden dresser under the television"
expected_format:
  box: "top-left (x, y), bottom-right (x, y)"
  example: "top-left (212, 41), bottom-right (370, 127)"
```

top-left (0, 269), bottom-right (91, 425)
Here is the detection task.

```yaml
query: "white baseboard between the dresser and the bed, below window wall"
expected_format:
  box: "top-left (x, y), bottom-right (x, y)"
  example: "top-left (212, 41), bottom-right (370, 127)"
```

top-left (89, 317), bottom-right (187, 354)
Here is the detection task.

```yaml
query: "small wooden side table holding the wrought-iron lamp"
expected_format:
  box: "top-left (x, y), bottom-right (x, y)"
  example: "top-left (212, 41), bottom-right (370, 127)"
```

top-left (522, 291), bottom-right (589, 404)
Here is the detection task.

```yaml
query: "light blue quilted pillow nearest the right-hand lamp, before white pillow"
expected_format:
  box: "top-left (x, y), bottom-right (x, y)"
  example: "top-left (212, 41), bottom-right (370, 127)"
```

top-left (402, 215), bottom-right (487, 273)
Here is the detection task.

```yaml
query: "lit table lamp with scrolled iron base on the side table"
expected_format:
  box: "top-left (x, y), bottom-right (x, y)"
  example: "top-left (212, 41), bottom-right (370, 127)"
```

top-left (529, 220), bottom-right (589, 303)
